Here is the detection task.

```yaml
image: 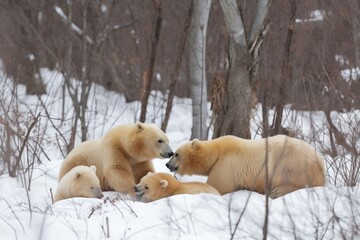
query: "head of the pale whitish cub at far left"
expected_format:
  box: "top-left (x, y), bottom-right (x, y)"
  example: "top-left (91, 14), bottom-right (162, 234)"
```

top-left (70, 166), bottom-right (104, 198)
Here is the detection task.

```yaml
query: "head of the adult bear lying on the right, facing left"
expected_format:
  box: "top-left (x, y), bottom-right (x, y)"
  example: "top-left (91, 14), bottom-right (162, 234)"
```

top-left (166, 139), bottom-right (212, 176)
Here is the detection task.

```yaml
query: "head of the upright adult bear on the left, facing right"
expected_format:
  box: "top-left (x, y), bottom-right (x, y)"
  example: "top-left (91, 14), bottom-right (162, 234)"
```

top-left (131, 122), bottom-right (174, 160)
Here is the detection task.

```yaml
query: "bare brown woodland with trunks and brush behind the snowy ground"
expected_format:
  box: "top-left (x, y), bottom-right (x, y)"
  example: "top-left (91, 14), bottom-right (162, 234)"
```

top-left (0, 0), bottom-right (360, 188)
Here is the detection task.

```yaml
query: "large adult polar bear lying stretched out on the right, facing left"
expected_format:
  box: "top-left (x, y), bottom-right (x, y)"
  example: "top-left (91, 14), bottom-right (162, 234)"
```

top-left (166, 135), bottom-right (326, 198)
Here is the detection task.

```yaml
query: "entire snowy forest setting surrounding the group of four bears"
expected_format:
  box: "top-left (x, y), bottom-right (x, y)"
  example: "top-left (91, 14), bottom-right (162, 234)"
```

top-left (0, 0), bottom-right (360, 239)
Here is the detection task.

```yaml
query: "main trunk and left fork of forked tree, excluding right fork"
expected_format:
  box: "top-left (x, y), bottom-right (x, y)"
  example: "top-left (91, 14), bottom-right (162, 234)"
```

top-left (214, 0), bottom-right (252, 138)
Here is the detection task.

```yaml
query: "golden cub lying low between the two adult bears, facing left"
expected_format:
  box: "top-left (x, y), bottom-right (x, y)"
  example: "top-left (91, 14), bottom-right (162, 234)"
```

top-left (134, 172), bottom-right (220, 202)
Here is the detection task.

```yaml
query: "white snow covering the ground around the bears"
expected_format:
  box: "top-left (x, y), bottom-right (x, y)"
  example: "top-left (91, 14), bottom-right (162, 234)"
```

top-left (0, 69), bottom-right (360, 240)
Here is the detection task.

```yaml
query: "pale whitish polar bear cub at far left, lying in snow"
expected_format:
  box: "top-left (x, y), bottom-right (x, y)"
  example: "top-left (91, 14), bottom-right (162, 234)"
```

top-left (54, 165), bottom-right (104, 203)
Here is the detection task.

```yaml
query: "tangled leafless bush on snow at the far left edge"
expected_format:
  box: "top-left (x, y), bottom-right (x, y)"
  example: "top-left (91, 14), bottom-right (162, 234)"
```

top-left (0, 77), bottom-right (44, 181)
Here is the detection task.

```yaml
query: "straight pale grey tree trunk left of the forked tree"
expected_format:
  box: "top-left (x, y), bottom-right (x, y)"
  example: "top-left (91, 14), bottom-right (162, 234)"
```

top-left (188, 0), bottom-right (211, 139)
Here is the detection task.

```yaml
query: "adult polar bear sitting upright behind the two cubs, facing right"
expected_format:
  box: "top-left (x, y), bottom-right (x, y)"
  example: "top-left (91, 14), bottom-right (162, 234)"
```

top-left (59, 122), bottom-right (173, 196)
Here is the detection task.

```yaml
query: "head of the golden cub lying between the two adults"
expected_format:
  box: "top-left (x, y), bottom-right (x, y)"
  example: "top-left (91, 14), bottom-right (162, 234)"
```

top-left (134, 172), bottom-right (176, 202)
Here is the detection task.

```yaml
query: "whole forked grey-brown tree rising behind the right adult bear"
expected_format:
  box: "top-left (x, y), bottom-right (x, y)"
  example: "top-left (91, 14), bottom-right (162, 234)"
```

top-left (214, 0), bottom-right (272, 138)
